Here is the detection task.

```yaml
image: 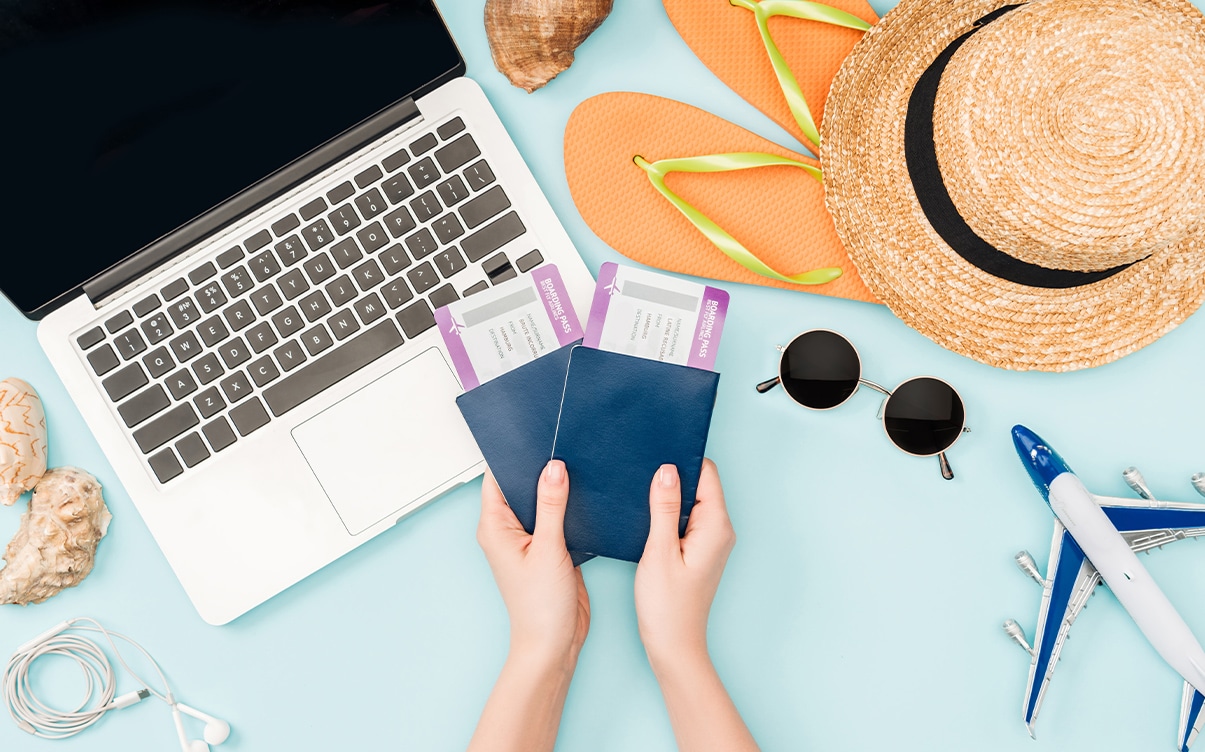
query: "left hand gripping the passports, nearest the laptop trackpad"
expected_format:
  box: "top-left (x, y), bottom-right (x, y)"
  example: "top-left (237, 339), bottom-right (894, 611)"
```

top-left (477, 460), bottom-right (590, 666)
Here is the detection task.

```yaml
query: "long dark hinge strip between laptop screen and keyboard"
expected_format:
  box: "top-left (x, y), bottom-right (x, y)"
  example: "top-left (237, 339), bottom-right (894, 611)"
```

top-left (83, 98), bottom-right (422, 309)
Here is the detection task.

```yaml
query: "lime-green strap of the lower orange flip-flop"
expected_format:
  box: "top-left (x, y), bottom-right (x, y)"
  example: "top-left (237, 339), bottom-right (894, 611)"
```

top-left (633, 152), bottom-right (841, 284)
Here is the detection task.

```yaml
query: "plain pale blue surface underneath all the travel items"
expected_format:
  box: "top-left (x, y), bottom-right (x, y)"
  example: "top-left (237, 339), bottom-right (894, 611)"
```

top-left (0, 0), bottom-right (1205, 752)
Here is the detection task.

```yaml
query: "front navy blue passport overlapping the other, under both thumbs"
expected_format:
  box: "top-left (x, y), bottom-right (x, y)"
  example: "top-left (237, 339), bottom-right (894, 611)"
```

top-left (551, 346), bottom-right (719, 562)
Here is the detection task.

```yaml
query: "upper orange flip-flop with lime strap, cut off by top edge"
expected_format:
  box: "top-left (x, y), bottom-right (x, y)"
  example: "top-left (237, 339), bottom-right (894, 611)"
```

top-left (664, 0), bottom-right (878, 153)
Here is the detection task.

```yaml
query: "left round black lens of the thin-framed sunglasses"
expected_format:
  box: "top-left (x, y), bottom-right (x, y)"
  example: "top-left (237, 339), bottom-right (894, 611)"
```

top-left (778, 331), bottom-right (862, 410)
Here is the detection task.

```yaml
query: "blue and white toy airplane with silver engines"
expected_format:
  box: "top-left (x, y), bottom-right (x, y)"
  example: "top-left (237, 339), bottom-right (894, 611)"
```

top-left (1004, 425), bottom-right (1205, 752)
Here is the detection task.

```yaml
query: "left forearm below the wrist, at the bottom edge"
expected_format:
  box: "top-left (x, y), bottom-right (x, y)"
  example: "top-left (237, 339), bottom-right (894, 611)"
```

top-left (469, 647), bottom-right (577, 752)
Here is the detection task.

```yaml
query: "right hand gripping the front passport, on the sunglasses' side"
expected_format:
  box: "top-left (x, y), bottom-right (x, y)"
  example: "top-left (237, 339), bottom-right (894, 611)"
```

top-left (636, 459), bottom-right (736, 670)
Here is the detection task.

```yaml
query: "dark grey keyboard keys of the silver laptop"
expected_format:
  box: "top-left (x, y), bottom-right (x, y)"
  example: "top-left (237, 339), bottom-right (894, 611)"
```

top-left (76, 118), bottom-right (543, 483)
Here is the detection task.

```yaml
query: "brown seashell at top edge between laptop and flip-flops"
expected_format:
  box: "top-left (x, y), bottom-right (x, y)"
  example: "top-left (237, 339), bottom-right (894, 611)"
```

top-left (486, 0), bottom-right (612, 94)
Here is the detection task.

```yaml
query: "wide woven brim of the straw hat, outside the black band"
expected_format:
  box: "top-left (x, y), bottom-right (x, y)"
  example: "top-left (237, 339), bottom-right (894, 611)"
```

top-left (821, 0), bottom-right (1205, 371)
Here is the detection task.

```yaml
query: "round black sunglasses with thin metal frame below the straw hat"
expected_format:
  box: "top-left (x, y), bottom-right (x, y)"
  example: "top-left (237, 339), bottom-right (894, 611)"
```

top-left (757, 329), bottom-right (970, 481)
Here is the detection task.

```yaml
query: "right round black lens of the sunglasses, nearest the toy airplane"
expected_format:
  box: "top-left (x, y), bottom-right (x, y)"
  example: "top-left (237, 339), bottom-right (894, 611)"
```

top-left (883, 377), bottom-right (965, 457)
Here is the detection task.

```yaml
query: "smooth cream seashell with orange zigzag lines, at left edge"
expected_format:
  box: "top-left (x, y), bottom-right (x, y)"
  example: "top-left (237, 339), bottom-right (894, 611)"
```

top-left (0, 378), bottom-right (46, 506)
